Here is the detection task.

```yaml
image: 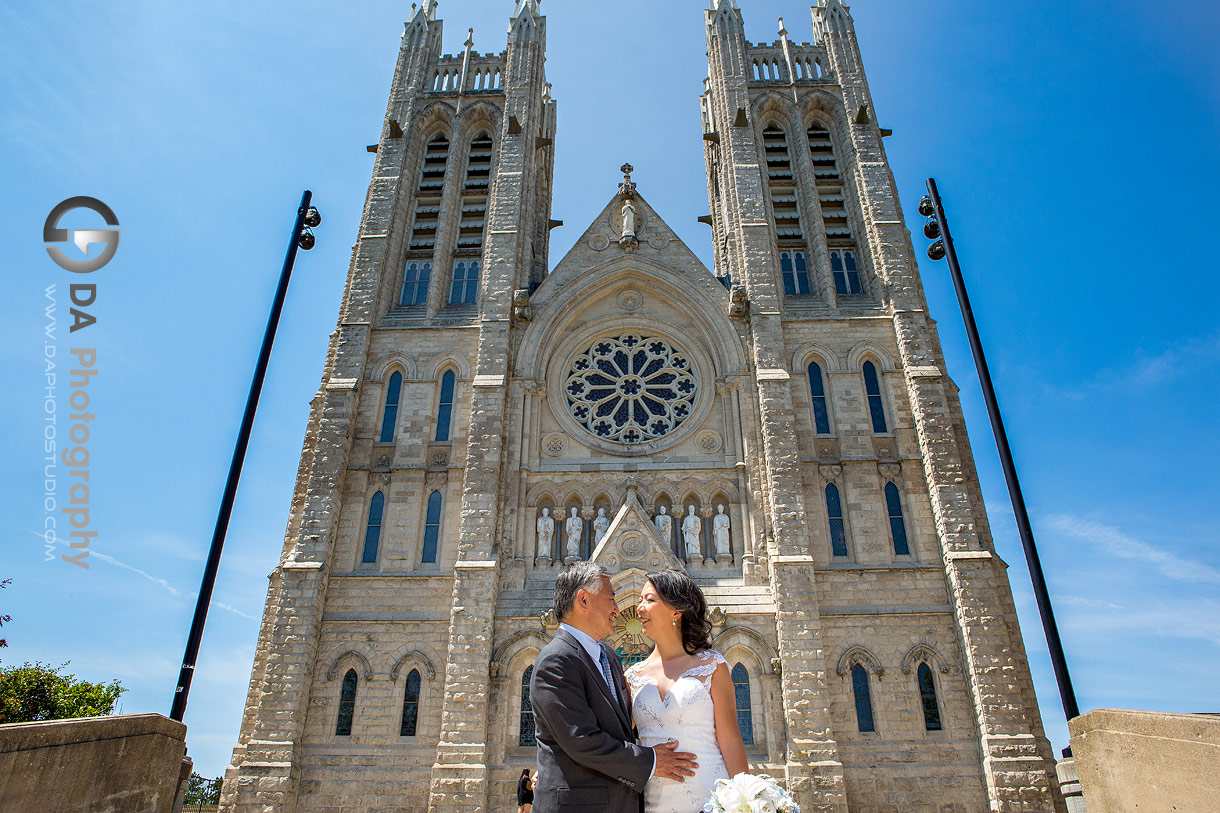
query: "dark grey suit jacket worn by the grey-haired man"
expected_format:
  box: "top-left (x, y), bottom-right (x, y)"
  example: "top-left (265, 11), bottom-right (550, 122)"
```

top-left (529, 630), bottom-right (654, 813)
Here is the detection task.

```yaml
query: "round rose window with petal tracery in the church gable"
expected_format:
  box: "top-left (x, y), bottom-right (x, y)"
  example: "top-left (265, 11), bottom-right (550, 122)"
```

top-left (564, 333), bottom-right (699, 443)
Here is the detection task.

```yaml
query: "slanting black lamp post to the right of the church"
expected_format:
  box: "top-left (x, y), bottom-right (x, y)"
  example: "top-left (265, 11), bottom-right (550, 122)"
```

top-left (919, 178), bottom-right (1080, 757)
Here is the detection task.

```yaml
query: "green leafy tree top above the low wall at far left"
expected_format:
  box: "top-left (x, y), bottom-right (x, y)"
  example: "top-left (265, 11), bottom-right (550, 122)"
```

top-left (0, 662), bottom-right (127, 723)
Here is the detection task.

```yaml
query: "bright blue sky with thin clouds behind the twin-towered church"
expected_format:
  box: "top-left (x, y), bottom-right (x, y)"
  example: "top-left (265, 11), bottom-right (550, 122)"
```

top-left (0, 0), bottom-right (1220, 775)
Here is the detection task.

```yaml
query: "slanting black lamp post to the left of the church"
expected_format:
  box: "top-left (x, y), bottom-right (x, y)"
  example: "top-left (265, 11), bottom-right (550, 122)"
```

top-left (170, 189), bottom-right (322, 723)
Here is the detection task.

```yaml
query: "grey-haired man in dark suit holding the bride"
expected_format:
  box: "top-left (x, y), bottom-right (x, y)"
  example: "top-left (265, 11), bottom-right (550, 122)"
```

top-left (529, 562), bottom-right (698, 813)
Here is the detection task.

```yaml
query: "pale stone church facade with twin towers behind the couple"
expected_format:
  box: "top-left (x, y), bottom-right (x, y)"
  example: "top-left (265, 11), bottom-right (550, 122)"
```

top-left (222, 0), bottom-right (1064, 813)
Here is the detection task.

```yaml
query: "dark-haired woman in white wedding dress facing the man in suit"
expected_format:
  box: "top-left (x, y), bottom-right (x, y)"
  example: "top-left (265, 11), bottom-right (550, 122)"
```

top-left (626, 570), bottom-right (749, 813)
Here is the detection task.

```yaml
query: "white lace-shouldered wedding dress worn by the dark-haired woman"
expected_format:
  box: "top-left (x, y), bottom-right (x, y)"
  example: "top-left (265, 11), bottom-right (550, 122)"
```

top-left (626, 649), bottom-right (728, 813)
